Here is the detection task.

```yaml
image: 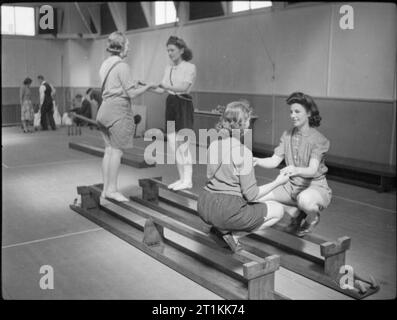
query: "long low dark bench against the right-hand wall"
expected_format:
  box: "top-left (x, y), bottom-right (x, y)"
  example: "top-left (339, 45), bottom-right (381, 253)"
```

top-left (253, 143), bottom-right (396, 192)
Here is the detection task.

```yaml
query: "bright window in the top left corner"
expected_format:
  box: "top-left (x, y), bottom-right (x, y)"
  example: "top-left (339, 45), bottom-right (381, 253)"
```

top-left (1, 6), bottom-right (35, 36)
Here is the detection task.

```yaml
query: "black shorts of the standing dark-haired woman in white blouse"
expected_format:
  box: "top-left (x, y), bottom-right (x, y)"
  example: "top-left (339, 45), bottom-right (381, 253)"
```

top-left (165, 94), bottom-right (194, 131)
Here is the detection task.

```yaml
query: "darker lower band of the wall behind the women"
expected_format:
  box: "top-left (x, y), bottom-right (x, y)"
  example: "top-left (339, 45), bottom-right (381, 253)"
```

top-left (2, 87), bottom-right (396, 165)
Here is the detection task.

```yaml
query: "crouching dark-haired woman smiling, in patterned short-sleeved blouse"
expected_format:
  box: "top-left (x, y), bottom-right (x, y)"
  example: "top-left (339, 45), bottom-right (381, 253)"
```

top-left (255, 92), bottom-right (332, 237)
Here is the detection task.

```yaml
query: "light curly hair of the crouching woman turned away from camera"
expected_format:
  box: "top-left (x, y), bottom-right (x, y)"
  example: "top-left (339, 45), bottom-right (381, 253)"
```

top-left (215, 100), bottom-right (252, 137)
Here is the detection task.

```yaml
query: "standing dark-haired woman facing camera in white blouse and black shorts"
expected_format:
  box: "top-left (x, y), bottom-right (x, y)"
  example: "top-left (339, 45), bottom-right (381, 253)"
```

top-left (157, 36), bottom-right (196, 190)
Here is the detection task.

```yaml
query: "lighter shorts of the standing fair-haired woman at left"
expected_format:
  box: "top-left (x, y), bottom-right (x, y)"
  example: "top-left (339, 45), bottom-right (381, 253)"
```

top-left (98, 115), bottom-right (135, 149)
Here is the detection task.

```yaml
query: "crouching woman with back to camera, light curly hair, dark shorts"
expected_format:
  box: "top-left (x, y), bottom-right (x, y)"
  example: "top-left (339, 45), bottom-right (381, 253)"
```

top-left (197, 101), bottom-right (289, 251)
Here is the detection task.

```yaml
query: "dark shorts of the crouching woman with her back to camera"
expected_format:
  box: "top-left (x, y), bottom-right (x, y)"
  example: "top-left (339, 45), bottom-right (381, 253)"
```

top-left (197, 190), bottom-right (267, 232)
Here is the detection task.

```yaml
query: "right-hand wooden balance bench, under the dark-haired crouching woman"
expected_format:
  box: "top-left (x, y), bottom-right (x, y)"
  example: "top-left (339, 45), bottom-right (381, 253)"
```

top-left (137, 177), bottom-right (379, 299)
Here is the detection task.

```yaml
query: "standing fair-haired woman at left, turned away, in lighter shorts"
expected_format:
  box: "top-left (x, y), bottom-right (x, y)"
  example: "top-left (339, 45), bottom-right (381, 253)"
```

top-left (96, 31), bottom-right (157, 201)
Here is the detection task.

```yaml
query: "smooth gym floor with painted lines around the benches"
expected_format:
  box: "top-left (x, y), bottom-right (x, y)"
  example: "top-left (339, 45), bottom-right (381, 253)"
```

top-left (2, 127), bottom-right (396, 300)
